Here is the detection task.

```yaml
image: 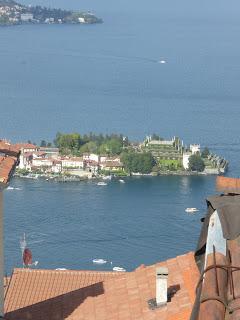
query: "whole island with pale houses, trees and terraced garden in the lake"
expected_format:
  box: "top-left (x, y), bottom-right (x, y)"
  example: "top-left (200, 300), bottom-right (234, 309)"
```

top-left (5, 133), bottom-right (228, 182)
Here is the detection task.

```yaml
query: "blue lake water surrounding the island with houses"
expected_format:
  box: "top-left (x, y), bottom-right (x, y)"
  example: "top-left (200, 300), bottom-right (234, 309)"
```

top-left (0, 0), bottom-right (240, 270)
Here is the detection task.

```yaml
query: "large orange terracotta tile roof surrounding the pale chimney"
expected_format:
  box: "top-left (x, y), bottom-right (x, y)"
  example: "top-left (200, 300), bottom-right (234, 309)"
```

top-left (5, 253), bottom-right (199, 320)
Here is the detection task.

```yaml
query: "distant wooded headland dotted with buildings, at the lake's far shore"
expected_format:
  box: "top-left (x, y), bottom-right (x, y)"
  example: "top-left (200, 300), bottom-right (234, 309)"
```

top-left (0, 0), bottom-right (103, 26)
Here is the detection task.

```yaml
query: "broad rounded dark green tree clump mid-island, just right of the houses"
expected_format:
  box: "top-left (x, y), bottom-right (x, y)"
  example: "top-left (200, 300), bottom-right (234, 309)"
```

top-left (121, 152), bottom-right (155, 174)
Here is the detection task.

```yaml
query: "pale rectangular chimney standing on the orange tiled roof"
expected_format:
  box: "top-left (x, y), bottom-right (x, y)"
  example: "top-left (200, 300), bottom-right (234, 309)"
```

top-left (156, 267), bottom-right (168, 307)
